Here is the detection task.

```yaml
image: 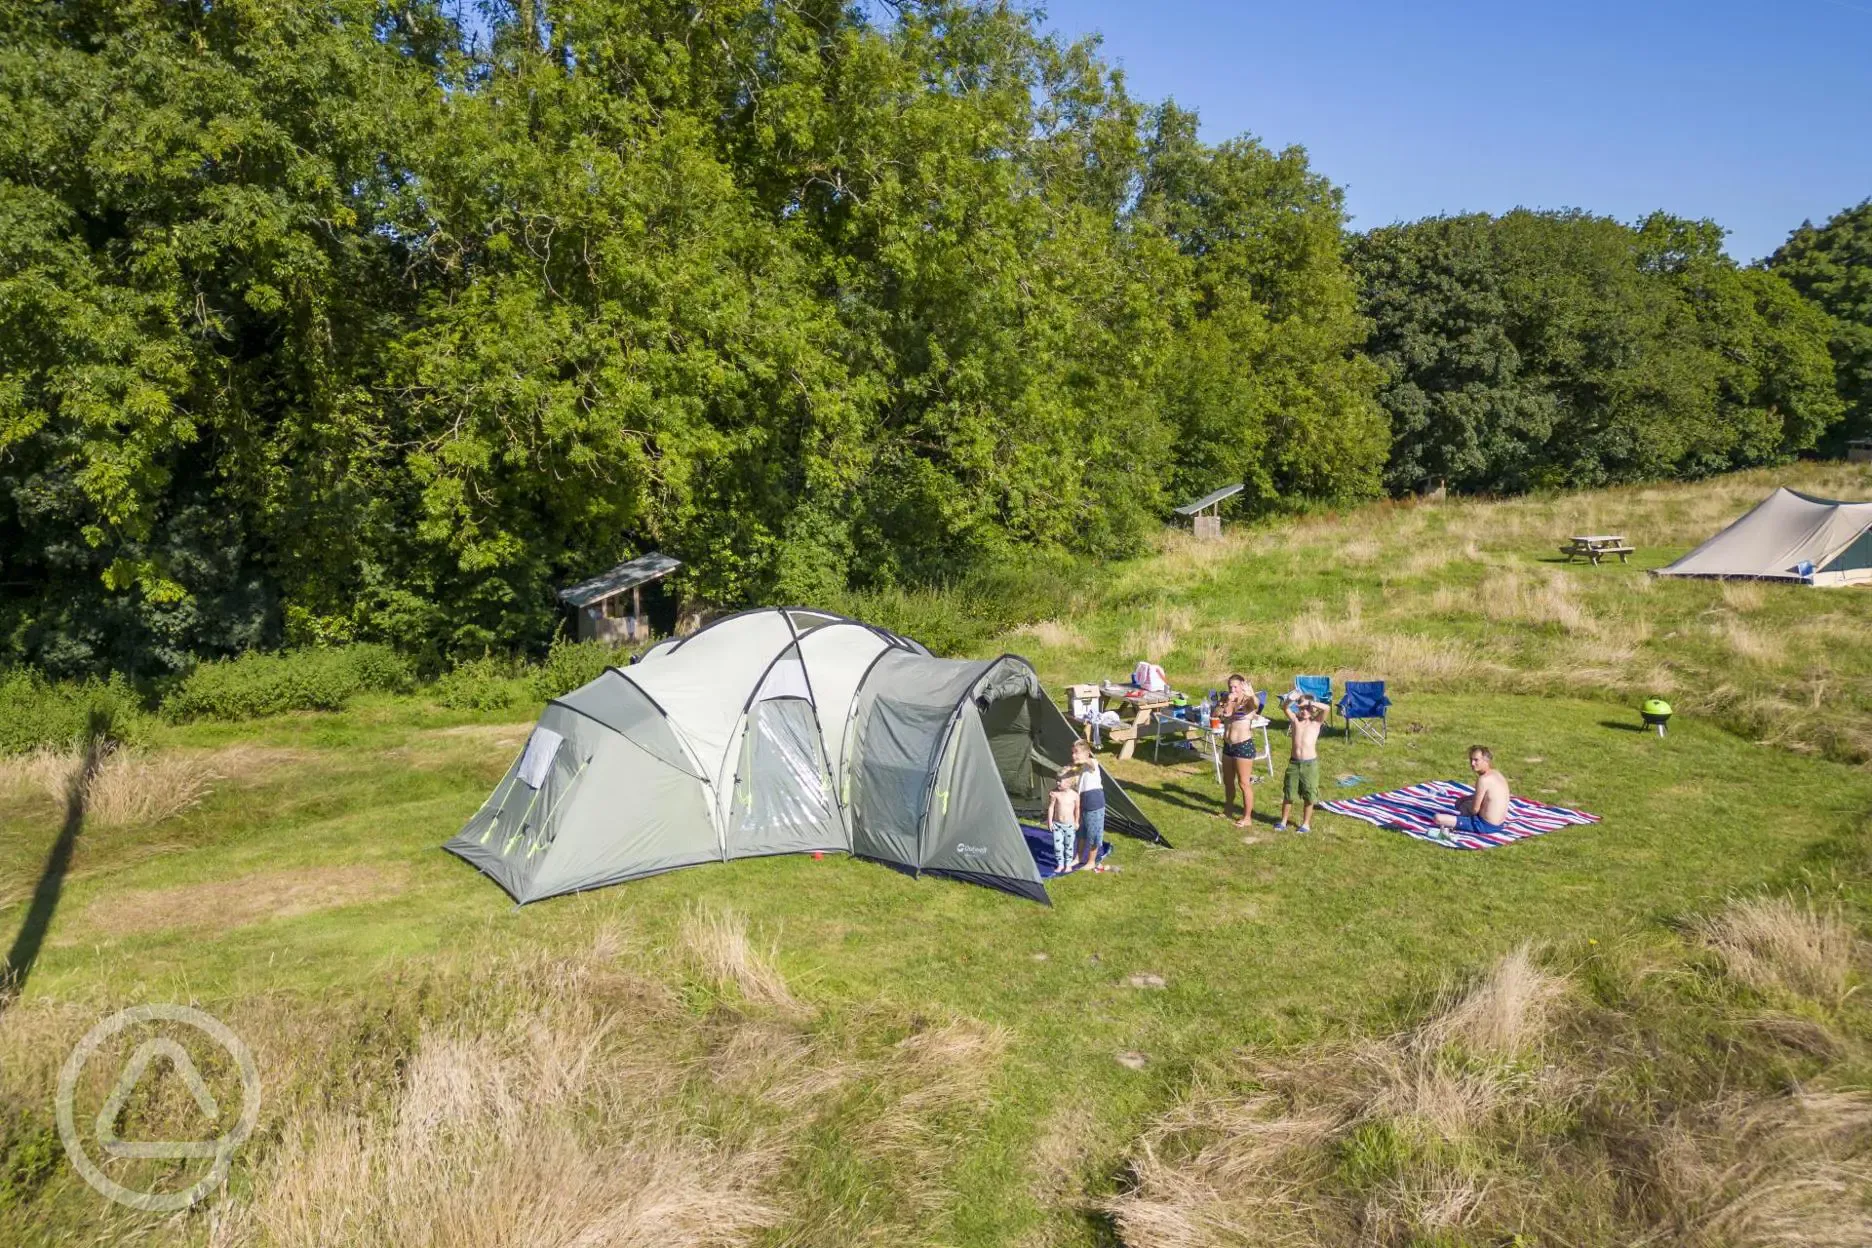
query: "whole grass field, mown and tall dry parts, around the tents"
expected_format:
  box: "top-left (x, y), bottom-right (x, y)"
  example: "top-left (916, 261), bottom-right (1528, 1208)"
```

top-left (0, 466), bottom-right (1872, 1248)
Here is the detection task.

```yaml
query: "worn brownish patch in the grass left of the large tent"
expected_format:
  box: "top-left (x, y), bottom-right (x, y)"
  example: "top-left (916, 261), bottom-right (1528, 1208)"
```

top-left (84, 864), bottom-right (408, 936)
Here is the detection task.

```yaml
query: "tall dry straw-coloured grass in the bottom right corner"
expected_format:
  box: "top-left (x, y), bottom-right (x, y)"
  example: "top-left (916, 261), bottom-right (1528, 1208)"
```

top-left (1104, 935), bottom-right (1872, 1248)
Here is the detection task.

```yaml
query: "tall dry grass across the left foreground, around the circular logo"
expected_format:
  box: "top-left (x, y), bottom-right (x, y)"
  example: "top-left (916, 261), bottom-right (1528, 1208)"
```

top-left (0, 911), bottom-right (1007, 1248)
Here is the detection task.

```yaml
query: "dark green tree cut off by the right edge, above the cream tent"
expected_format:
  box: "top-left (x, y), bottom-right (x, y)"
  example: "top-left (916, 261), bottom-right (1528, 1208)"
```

top-left (1767, 198), bottom-right (1872, 453)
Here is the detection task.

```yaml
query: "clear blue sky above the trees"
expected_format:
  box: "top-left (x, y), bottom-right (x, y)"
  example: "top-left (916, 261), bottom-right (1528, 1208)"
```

top-left (1045, 0), bottom-right (1872, 260)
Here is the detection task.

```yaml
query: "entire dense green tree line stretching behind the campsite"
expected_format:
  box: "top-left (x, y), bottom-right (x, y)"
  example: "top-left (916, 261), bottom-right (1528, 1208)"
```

top-left (0, 0), bottom-right (1853, 674)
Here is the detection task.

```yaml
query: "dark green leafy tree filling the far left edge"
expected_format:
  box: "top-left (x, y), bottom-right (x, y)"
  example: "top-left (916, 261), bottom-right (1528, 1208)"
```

top-left (0, 0), bottom-right (449, 668)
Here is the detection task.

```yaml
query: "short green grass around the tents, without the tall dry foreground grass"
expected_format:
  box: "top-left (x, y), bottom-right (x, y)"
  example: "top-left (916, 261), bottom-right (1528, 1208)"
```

top-left (0, 470), bottom-right (1872, 1244)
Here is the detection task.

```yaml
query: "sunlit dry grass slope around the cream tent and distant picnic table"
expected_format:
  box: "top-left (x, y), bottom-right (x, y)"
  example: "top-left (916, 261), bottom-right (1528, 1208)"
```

top-left (1084, 464), bottom-right (1872, 763)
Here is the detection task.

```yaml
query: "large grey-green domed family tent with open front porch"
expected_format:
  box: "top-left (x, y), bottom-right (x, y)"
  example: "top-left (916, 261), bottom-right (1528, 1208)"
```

top-left (446, 610), bottom-right (1163, 904)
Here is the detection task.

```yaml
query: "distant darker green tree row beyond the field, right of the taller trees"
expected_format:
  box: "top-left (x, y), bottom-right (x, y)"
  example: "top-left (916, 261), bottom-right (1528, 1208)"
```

top-left (1353, 211), bottom-right (1840, 490)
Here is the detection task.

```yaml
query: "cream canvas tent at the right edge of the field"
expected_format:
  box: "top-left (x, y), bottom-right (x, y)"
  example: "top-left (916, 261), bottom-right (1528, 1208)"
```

top-left (1657, 488), bottom-right (1872, 586)
